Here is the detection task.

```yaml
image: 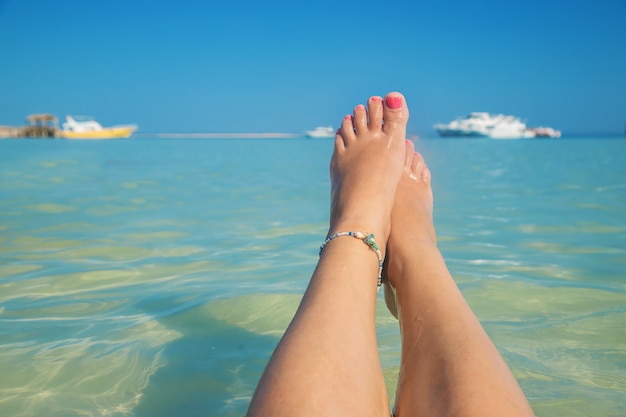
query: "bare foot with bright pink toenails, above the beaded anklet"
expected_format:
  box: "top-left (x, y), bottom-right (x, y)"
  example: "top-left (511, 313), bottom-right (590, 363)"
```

top-left (329, 92), bottom-right (409, 252)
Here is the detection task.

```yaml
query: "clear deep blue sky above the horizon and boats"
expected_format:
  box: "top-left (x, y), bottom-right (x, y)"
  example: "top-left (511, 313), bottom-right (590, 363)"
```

top-left (0, 0), bottom-right (626, 135)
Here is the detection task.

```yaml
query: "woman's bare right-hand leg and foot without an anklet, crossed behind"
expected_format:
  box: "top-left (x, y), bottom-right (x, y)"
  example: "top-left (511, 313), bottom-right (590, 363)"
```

top-left (385, 143), bottom-right (533, 417)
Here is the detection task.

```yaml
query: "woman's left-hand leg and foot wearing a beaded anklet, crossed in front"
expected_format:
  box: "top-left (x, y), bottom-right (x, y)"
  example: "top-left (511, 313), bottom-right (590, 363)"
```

top-left (248, 93), bottom-right (409, 417)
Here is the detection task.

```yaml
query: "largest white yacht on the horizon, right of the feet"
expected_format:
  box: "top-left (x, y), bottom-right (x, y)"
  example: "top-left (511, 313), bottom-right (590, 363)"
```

top-left (434, 112), bottom-right (535, 139)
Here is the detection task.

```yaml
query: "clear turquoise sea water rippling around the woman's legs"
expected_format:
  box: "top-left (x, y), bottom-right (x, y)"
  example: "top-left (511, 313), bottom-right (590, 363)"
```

top-left (0, 138), bottom-right (626, 417)
